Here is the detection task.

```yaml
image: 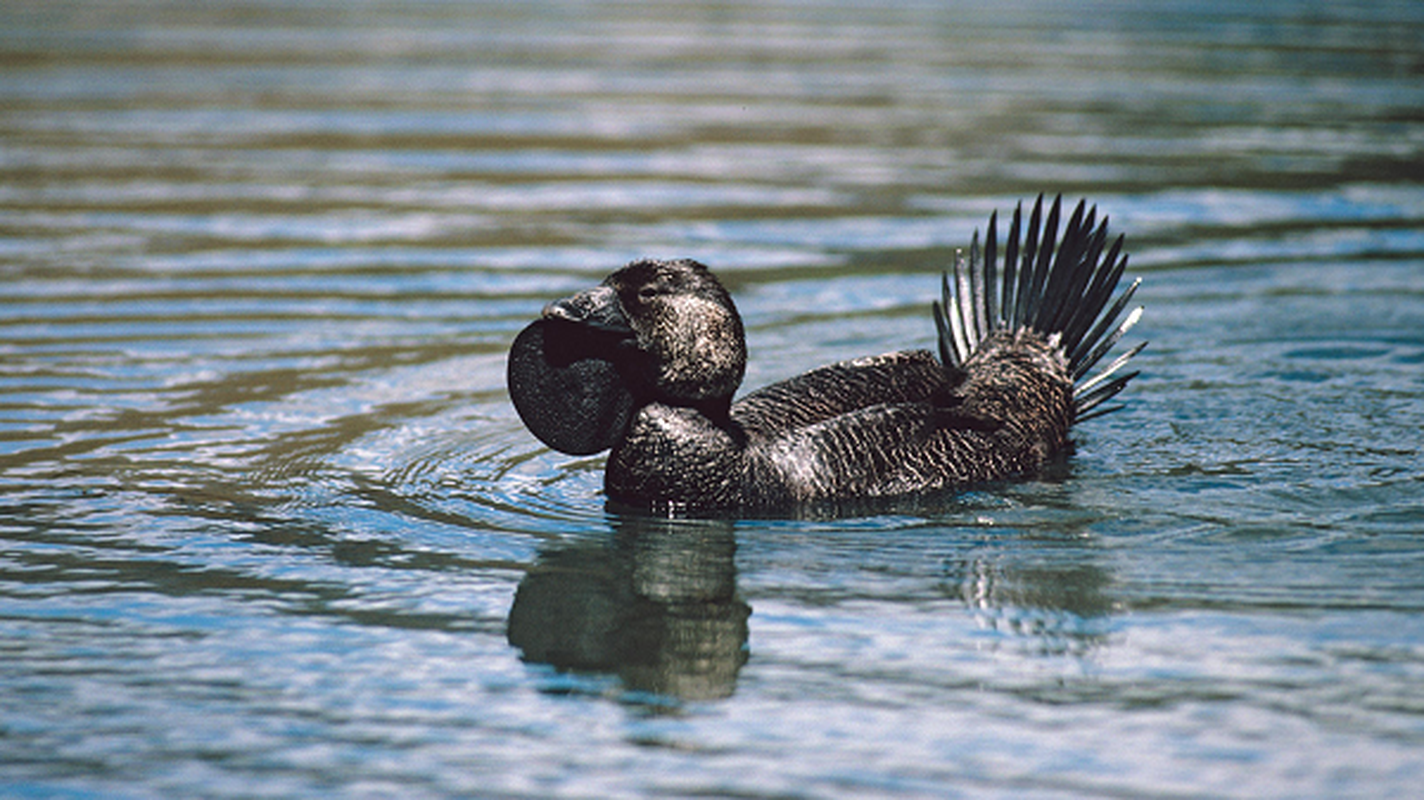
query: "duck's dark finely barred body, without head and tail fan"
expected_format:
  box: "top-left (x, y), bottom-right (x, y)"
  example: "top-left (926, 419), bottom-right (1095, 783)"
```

top-left (605, 341), bottom-right (1072, 510)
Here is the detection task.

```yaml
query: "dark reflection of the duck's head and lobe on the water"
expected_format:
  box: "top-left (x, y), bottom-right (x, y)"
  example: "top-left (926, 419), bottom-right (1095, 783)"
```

top-left (508, 517), bottom-right (752, 700)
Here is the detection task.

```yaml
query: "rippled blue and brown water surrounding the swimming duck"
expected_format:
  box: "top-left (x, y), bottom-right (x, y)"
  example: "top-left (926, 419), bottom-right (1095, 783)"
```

top-left (0, 0), bottom-right (1424, 797)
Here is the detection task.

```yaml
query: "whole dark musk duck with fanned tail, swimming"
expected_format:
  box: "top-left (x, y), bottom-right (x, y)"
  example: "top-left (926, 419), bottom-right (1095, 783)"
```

top-left (507, 195), bottom-right (1146, 514)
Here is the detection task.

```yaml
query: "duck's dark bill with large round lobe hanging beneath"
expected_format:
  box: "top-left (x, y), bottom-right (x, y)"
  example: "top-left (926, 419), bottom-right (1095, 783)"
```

top-left (506, 286), bottom-right (634, 456)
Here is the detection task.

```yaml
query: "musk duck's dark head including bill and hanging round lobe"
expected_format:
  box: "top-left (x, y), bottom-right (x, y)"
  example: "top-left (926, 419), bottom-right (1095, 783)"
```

top-left (508, 259), bottom-right (746, 456)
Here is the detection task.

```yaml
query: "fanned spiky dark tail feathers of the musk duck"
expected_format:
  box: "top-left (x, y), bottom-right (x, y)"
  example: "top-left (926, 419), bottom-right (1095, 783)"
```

top-left (934, 195), bottom-right (1146, 421)
